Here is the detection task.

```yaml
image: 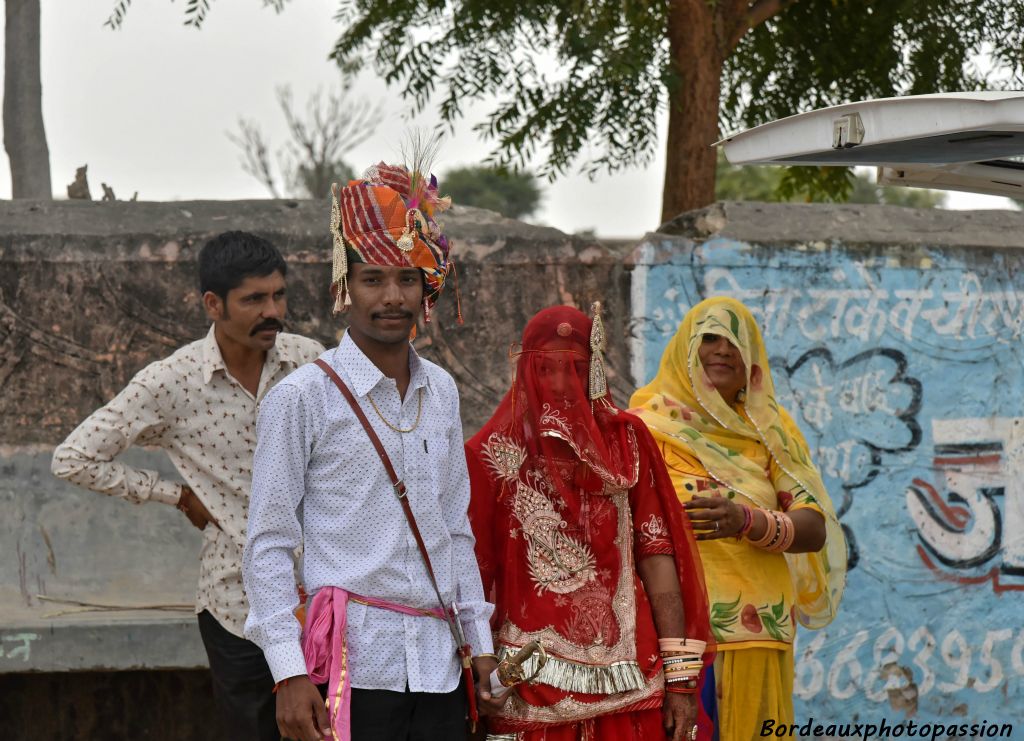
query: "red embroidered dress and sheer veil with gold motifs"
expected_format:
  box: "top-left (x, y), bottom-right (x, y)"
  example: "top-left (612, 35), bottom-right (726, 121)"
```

top-left (467, 306), bottom-right (711, 738)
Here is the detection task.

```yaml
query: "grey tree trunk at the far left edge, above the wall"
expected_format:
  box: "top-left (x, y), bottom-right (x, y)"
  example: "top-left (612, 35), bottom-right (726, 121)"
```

top-left (3, 0), bottom-right (53, 200)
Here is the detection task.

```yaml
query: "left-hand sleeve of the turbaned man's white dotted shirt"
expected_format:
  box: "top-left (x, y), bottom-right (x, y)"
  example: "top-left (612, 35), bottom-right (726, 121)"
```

top-left (242, 384), bottom-right (313, 682)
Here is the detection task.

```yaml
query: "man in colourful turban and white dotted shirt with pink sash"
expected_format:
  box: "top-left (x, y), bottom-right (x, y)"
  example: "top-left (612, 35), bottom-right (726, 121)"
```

top-left (243, 163), bottom-right (501, 741)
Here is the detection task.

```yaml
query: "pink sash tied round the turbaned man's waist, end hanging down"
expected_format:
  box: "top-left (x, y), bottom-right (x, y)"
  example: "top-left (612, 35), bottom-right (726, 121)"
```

top-left (302, 586), bottom-right (444, 741)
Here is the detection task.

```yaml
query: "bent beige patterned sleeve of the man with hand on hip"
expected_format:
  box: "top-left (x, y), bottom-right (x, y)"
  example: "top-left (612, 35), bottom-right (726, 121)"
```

top-left (50, 377), bottom-right (181, 505)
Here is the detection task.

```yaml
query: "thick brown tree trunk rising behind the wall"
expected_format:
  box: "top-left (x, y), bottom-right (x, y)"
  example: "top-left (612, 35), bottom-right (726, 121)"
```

top-left (662, 0), bottom-right (724, 223)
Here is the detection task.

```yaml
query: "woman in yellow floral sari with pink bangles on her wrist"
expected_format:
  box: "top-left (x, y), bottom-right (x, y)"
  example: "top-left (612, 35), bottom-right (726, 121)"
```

top-left (630, 298), bottom-right (846, 741)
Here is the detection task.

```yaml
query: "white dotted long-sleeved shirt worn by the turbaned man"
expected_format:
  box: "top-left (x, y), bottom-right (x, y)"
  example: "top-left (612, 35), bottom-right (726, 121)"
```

top-left (243, 334), bottom-right (494, 693)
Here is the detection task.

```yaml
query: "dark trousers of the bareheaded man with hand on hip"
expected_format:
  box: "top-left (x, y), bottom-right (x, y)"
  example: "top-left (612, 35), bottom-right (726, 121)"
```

top-left (199, 610), bottom-right (281, 741)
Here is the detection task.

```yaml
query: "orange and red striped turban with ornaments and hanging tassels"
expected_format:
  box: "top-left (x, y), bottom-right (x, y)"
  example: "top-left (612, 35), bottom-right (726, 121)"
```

top-left (331, 162), bottom-right (461, 321)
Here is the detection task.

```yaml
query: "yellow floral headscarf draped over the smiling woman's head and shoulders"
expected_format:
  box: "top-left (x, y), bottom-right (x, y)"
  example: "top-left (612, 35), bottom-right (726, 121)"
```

top-left (630, 297), bottom-right (847, 628)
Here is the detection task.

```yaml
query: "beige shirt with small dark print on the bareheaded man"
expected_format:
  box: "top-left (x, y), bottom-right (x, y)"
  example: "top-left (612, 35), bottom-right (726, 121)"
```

top-left (52, 326), bottom-right (324, 636)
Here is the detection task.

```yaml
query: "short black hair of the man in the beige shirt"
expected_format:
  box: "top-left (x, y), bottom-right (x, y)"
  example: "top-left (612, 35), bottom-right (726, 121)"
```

top-left (199, 231), bottom-right (288, 301)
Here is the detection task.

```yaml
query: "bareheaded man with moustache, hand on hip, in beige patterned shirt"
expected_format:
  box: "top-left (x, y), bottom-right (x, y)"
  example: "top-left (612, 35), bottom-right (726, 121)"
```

top-left (52, 231), bottom-right (324, 741)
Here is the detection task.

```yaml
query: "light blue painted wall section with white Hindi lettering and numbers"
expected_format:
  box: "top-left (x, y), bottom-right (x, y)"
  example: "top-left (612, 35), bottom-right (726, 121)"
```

top-left (633, 237), bottom-right (1024, 738)
